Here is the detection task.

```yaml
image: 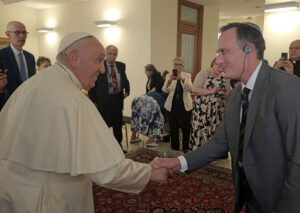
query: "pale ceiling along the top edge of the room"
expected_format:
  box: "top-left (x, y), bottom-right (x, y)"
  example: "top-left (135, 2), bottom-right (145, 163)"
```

top-left (2, 0), bottom-right (298, 19)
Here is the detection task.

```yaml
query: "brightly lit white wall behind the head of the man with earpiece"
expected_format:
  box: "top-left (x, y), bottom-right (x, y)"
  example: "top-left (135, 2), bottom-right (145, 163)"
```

top-left (263, 10), bottom-right (300, 66)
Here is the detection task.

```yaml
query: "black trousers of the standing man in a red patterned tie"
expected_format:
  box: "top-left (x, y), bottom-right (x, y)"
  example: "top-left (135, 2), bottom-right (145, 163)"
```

top-left (101, 94), bottom-right (123, 147)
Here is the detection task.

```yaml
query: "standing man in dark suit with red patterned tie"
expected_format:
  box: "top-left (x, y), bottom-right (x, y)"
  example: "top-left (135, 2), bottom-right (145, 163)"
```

top-left (89, 45), bottom-right (130, 151)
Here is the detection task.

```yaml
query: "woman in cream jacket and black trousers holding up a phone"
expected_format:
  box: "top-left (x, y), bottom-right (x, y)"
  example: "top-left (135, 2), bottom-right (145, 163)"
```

top-left (162, 57), bottom-right (193, 152)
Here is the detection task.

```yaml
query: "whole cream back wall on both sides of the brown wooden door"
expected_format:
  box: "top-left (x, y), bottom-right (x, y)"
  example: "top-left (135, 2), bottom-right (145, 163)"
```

top-left (0, 0), bottom-right (218, 116)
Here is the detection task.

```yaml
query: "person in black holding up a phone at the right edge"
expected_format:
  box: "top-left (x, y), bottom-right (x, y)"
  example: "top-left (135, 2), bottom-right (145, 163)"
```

top-left (274, 40), bottom-right (300, 77)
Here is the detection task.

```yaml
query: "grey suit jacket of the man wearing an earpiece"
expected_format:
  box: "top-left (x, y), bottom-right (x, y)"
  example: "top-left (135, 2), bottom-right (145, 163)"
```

top-left (185, 63), bottom-right (300, 213)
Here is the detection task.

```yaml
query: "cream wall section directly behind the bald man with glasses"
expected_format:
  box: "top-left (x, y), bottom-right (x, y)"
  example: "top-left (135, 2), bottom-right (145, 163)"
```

top-left (0, 1), bottom-right (38, 58)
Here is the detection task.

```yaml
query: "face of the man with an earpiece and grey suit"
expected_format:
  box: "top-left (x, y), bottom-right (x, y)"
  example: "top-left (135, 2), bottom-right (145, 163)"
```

top-left (216, 28), bottom-right (246, 79)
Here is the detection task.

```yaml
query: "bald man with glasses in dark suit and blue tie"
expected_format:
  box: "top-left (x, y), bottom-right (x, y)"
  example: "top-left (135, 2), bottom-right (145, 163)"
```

top-left (0, 21), bottom-right (35, 110)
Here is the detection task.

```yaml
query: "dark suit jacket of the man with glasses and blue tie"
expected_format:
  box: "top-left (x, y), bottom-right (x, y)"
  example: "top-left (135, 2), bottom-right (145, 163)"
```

top-left (0, 45), bottom-right (35, 110)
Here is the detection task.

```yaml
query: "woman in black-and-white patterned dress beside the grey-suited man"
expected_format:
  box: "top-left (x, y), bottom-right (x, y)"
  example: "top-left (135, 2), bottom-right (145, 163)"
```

top-left (189, 58), bottom-right (230, 150)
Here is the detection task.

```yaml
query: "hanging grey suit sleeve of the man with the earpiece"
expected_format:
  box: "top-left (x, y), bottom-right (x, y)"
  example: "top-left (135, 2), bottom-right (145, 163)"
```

top-left (275, 78), bottom-right (300, 212)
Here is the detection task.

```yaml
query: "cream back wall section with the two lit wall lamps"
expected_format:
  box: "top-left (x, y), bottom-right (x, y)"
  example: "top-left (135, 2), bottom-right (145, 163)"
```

top-left (38, 0), bottom-right (151, 116)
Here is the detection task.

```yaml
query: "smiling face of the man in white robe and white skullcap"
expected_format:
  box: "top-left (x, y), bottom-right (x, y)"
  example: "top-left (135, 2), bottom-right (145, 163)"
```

top-left (76, 38), bottom-right (105, 91)
